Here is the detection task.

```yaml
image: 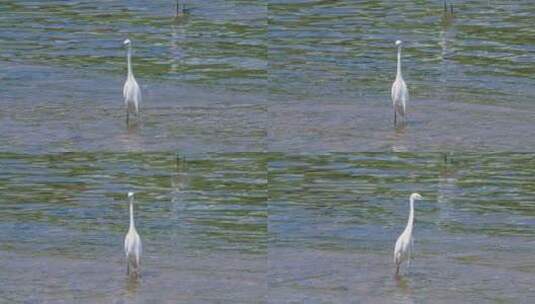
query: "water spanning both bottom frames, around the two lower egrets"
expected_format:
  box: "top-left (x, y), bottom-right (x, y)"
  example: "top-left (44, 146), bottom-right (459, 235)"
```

top-left (0, 153), bottom-right (535, 303)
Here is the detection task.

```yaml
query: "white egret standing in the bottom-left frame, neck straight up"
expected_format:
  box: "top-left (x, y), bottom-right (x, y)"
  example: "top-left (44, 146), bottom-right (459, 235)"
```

top-left (124, 192), bottom-right (142, 277)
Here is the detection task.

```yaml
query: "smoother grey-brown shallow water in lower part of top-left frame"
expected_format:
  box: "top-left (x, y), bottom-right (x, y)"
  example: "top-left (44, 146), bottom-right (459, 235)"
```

top-left (0, 64), bottom-right (267, 153)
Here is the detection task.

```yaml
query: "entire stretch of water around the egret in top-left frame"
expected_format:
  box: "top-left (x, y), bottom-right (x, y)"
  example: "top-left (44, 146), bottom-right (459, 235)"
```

top-left (0, 0), bottom-right (267, 153)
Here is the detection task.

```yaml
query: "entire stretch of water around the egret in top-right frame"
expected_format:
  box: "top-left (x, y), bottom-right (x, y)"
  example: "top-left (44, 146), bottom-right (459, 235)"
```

top-left (268, 0), bottom-right (535, 153)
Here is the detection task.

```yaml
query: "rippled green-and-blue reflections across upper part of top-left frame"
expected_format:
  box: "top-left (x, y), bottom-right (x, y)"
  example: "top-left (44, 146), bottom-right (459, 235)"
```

top-left (0, 0), bottom-right (267, 92)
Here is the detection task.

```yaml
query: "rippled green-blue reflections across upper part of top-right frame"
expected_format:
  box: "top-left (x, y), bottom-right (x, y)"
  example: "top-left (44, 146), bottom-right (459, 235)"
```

top-left (268, 0), bottom-right (535, 105)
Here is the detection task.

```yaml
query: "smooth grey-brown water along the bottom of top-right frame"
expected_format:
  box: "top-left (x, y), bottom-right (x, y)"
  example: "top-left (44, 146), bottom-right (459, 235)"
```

top-left (266, 96), bottom-right (535, 153)
